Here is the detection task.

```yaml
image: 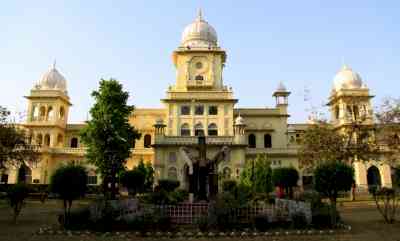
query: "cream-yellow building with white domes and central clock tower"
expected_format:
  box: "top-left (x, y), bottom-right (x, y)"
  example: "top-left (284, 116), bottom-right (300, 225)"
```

top-left (1, 13), bottom-right (392, 191)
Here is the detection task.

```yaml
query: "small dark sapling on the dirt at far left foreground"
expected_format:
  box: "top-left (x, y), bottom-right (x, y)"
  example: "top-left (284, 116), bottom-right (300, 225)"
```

top-left (7, 183), bottom-right (30, 224)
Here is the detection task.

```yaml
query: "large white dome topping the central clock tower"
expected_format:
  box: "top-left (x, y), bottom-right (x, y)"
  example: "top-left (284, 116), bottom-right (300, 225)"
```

top-left (181, 11), bottom-right (218, 47)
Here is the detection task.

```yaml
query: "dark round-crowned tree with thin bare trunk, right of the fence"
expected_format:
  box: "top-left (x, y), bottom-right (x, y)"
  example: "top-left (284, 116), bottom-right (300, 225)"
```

top-left (314, 161), bottom-right (354, 225)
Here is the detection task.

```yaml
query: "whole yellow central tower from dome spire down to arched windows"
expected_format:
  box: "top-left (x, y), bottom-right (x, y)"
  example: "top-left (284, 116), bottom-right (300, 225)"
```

top-left (162, 11), bottom-right (237, 136)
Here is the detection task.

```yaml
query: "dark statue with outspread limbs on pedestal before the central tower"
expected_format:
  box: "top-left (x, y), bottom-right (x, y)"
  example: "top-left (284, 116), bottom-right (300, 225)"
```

top-left (179, 136), bottom-right (229, 200)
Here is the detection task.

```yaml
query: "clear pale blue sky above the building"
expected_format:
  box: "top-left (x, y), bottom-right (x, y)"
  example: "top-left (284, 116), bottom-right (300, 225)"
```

top-left (0, 0), bottom-right (400, 123)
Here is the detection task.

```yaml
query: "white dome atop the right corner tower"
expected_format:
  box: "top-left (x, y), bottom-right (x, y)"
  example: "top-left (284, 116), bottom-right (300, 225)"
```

top-left (333, 65), bottom-right (363, 91)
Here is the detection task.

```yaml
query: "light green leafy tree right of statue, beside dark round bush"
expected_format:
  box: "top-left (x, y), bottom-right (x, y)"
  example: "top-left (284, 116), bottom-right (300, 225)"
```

top-left (240, 155), bottom-right (272, 193)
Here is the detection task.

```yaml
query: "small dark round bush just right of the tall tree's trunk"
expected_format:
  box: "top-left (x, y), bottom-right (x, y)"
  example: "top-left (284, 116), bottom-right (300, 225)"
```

top-left (120, 168), bottom-right (146, 196)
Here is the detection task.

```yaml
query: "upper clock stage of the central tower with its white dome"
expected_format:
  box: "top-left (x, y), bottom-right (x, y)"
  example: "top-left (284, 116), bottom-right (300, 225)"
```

top-left (172, 11), bottom-right (226, 90)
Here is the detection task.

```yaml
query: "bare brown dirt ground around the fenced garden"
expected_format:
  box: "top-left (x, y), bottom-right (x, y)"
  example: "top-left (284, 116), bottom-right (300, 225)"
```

top-left (0, 200), bottom-right (400, 241)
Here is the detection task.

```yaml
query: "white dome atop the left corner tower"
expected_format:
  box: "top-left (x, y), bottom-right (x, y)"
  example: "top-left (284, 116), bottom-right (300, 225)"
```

top-left (36, 61), bottom-right (67, 92)
